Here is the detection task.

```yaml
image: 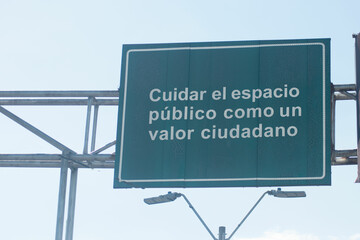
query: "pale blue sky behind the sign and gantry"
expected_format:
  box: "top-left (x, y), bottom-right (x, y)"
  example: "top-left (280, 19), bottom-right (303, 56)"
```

top-left (0, 0), bottom-right (360, 240)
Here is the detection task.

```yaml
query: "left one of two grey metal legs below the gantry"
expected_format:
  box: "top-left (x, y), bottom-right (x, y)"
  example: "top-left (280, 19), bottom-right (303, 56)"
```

top-left (55, 158), bottom-right (68, 240)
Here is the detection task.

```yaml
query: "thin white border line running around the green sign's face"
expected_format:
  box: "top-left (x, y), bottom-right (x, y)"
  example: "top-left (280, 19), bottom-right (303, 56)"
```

top-left (118, 42), bottom-right (326, 183)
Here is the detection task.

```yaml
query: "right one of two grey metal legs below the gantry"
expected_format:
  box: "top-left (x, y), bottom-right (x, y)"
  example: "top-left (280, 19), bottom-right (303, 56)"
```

top-left (65, 168), bottom-right (78, 240)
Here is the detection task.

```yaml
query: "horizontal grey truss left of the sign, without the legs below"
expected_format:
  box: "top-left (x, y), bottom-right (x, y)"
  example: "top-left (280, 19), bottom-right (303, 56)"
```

top-left (0, 91), bottom-right (119, 168)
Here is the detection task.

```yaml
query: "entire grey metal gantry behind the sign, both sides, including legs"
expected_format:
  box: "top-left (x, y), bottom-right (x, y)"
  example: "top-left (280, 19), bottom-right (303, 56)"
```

top-left (0, 84), bottom-right (357, 240)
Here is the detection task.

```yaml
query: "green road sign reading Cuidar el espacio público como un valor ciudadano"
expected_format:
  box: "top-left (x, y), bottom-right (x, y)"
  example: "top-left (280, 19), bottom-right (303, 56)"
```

top-left (114, 39), bottom-right (331, 188)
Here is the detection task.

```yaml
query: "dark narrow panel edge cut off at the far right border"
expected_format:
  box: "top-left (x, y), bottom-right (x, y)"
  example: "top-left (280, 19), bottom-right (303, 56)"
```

top-left (353, 33), bottom-right (360, 183)
